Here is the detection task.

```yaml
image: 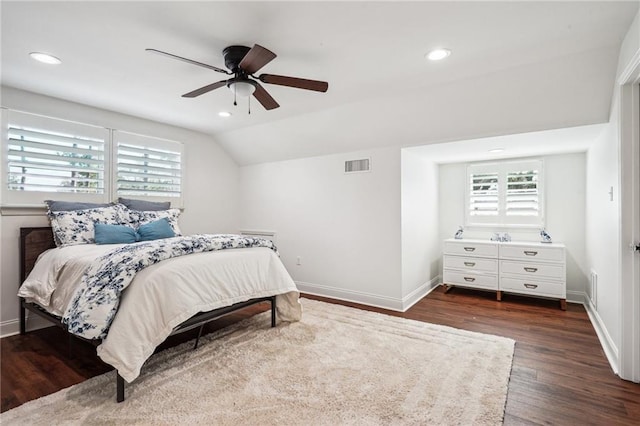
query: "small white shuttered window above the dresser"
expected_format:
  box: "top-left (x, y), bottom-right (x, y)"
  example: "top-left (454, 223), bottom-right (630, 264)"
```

top-left (465, 160), bottom-right (544, 227)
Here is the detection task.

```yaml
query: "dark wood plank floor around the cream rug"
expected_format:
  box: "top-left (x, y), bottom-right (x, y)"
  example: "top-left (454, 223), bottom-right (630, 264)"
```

top-left (0, 288), bottom-right (640, 425)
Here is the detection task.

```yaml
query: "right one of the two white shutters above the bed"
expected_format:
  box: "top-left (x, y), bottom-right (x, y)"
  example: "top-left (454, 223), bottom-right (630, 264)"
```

top-left (114, 131), bottom-right (183, 205)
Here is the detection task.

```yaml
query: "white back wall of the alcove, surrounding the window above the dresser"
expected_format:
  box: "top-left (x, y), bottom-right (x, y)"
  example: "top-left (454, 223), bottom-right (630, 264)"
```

top-left (438, 153), bottom-right (588, 302)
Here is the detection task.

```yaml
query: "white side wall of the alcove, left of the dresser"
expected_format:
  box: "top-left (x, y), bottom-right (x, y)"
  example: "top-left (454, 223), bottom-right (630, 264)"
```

top-left (401, 149), bottom-right (441, 309)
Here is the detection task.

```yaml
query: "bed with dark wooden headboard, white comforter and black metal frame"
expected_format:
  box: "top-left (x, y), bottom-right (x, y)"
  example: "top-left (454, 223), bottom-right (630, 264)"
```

top-left (18, 227), bottom-right (301, 402)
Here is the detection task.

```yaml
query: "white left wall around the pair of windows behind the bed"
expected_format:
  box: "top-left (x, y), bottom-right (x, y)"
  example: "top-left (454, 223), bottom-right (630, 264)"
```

top-left (0, 87), bottom-right (239, 335)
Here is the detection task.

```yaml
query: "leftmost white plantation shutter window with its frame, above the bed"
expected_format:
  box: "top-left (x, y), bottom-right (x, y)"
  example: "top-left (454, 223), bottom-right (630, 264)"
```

top-left (2, 111), bottom-right (109, 204)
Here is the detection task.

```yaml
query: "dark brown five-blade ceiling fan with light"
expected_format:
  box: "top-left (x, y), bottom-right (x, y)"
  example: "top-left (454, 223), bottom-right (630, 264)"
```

top-left (146, 44), bottom-right (329, 113)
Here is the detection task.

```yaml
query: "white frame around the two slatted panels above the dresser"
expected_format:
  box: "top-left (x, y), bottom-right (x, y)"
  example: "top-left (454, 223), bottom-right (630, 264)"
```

top-left (464, 158), bottom-right (546, 228)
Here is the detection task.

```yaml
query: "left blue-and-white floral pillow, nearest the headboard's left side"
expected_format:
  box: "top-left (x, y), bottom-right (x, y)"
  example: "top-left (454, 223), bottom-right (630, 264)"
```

top-left (47, 204), bottom-right (131, 247)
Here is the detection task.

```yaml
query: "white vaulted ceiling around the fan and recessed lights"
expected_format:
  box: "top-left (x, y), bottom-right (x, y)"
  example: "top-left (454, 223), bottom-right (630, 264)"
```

top-left (0, 1), bottom-right (638, 164)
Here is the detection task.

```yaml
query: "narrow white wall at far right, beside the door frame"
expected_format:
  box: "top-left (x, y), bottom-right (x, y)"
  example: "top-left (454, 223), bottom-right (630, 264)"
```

top-left (586, 12), bottom-right (640, 372)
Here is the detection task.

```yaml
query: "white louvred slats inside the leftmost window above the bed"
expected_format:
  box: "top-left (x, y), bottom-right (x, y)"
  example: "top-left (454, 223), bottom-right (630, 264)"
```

top-left (6, 115), bottom-right (105, 194)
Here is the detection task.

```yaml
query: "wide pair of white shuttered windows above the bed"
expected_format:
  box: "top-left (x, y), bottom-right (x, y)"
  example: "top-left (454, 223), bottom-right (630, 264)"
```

top-left (1, 109), bottom-right (184, 207)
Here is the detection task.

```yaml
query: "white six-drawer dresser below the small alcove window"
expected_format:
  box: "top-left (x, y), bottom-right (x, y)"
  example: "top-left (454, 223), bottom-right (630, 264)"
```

top-left (442, 239), bottom-right (567, 310)
